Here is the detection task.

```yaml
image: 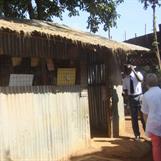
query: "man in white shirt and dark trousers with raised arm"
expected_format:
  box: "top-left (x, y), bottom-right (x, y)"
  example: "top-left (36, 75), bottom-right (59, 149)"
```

top-left (123, 64), bottom-right (145, 140)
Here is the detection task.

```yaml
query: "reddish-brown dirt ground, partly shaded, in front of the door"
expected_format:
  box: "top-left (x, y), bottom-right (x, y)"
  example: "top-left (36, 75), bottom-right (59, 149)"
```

top-left (70, 119), bottom-right (153, 161)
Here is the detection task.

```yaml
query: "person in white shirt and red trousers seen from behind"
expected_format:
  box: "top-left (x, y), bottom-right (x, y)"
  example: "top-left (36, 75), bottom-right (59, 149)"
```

top-left (141, 73), bottom-right (161, 161)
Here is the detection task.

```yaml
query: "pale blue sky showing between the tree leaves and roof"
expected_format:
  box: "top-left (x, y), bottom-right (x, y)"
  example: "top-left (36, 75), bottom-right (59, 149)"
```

top-left (54, 0), bottom-right (161, 41)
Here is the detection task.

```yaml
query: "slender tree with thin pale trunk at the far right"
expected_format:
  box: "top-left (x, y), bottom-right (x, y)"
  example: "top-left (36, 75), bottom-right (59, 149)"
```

top-left (140, 0), bottom-right (161, 69)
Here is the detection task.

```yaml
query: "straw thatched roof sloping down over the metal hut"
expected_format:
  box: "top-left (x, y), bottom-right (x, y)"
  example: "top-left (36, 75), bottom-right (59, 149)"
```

top-left (0, 19), bottom-right (149, 51)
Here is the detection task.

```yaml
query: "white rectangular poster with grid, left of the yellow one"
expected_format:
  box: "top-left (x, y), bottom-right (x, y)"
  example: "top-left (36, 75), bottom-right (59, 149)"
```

top-left (9, 74), bottom-right (34, 86)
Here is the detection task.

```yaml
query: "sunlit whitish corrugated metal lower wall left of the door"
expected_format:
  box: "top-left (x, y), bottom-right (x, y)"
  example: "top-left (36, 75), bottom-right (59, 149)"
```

top-left (0, 86), bottom-right (90, 161)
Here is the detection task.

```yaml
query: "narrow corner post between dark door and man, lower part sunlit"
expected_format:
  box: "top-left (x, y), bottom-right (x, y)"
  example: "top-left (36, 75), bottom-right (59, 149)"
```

top-left (106, 53), bottom-right (125, 137)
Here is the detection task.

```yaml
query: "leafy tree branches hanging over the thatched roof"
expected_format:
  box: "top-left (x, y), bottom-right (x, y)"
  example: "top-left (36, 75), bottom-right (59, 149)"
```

top-left (0, 0), bottom-right (124, 32)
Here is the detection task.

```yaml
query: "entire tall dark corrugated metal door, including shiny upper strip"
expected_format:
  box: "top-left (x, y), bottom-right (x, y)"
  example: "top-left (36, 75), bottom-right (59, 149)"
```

top-left (87, 53), bottom-right (110, 137)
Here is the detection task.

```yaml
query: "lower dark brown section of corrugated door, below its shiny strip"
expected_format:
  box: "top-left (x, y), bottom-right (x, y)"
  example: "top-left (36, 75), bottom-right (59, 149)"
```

top-left (88, 86), bottom-right (109, 137)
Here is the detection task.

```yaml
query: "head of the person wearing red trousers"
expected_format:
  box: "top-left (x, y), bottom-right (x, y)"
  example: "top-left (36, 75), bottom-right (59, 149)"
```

top-left (145, 73), bottom-right (158, 88)
